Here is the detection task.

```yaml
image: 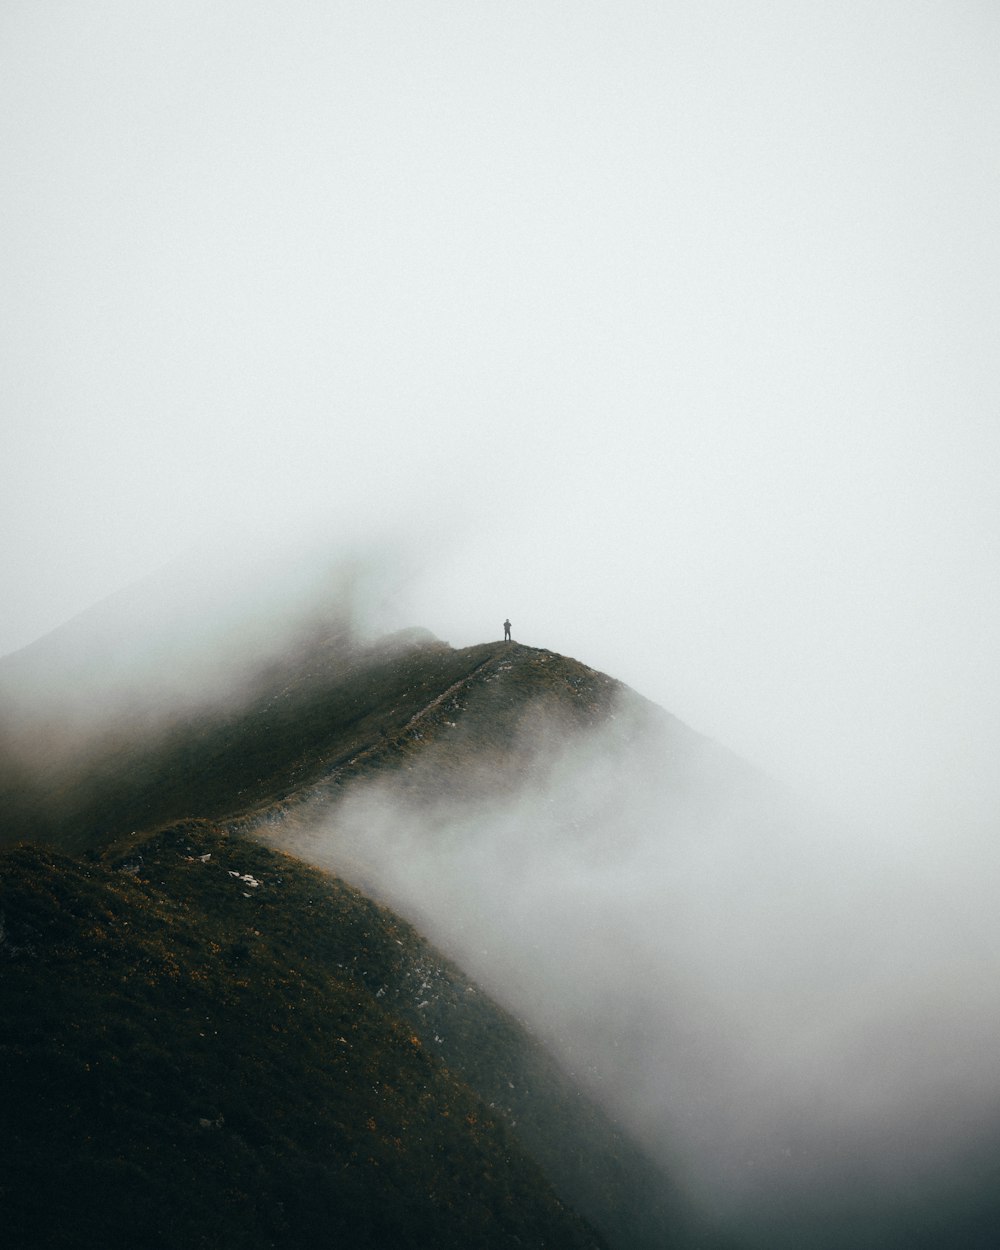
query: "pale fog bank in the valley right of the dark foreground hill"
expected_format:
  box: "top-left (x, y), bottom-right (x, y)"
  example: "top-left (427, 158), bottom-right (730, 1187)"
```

top-left (276, 699), bottom-right (1000, 1250)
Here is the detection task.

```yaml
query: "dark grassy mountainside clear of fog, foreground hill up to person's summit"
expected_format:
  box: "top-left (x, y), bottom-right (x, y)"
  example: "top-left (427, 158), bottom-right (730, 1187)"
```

top-left (0, 631), bottom-right (705, 1250)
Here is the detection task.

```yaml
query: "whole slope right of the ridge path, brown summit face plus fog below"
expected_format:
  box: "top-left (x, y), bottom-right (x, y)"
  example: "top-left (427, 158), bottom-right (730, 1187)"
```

top-left (243, 644), bottom-right (1000, 1250)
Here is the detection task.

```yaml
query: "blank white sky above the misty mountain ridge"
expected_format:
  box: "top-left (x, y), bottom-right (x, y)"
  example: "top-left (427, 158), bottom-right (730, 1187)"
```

top-left (0, 7), bottom-right (1000, 821)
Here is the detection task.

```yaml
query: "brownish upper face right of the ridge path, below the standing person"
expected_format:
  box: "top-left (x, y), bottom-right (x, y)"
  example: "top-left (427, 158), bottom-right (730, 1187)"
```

top-left (243, 643), bottom-right (740, 850)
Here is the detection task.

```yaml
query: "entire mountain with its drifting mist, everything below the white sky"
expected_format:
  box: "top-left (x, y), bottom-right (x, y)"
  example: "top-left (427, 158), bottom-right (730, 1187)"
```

top-left (0, 587), bottom-right (1000, 1250)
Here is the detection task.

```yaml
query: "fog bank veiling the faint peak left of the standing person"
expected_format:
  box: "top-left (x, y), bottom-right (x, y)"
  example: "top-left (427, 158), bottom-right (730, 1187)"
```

top-left (0, 531), bottom-right (413, 845)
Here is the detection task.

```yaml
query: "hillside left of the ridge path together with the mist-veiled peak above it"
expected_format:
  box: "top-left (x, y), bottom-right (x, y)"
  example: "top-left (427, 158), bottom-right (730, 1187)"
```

top-left (0, 547), bottom-right (479, 849)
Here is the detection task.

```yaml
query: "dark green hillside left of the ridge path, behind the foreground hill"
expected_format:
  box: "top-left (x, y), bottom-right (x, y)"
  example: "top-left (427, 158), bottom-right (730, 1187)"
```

top-left (0, 630), bottom-right (494, 850)
